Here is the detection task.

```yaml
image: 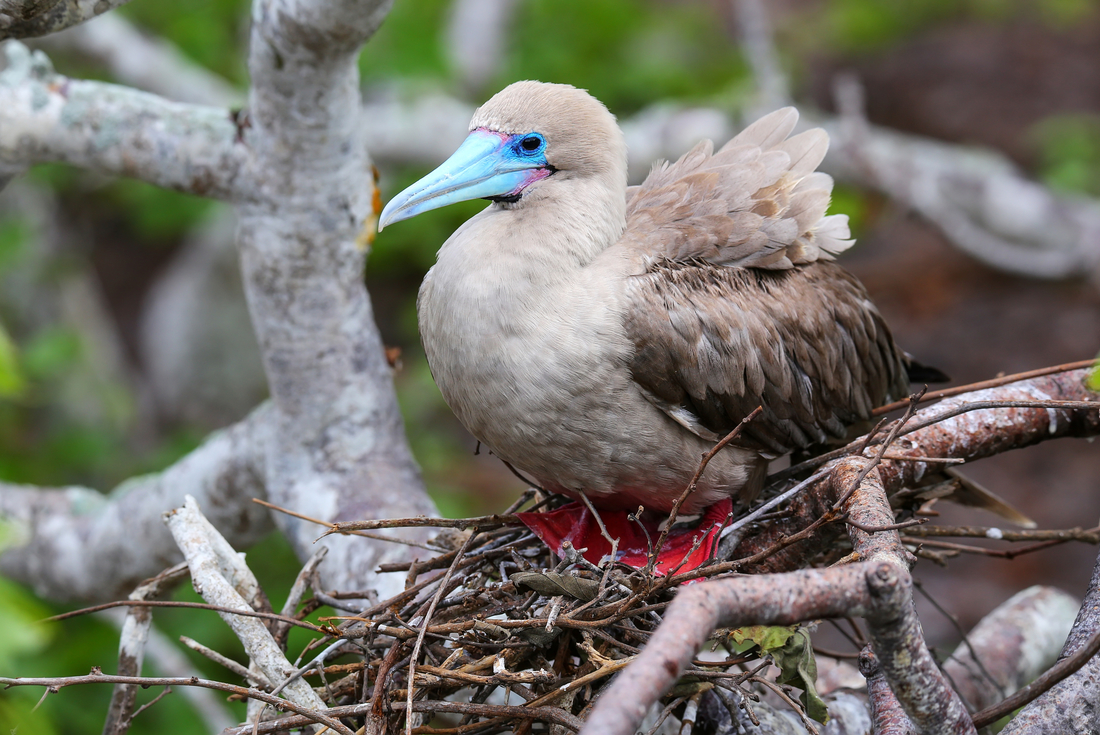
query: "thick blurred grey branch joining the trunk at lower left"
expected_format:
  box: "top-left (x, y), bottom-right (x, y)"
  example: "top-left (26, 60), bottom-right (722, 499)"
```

top-left (0, 406), bottom-right (272, 601)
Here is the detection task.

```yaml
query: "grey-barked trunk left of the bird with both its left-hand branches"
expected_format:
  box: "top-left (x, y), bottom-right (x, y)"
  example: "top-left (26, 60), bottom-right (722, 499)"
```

top-left (0, 0), bottom-right (435, 599)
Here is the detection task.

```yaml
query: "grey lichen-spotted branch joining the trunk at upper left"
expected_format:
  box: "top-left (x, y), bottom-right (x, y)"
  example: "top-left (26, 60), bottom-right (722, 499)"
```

top-left (0, 42), bottom-right (251, 199)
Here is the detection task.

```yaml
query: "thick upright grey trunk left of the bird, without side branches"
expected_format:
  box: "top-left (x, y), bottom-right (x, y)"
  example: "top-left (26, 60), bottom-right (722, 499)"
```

top-left (238, 0), bottom-right (435, 596)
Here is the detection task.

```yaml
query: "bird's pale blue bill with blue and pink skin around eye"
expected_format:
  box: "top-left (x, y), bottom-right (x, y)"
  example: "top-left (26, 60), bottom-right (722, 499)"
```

top-left (378, 128), bottom-right (554, 227)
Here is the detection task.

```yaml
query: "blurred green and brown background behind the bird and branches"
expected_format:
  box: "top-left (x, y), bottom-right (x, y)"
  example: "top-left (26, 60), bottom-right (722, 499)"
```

top-left (0, 0), bottom-right (1100, 734)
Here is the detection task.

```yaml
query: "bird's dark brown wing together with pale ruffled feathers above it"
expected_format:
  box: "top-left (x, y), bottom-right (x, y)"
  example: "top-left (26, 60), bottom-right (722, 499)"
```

top-left (616, 108), bottom-right (908, 452)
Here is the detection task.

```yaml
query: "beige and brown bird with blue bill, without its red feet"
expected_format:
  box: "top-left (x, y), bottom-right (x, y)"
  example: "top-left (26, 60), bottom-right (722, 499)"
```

top-left (378, 80), bottom-right (919, 515)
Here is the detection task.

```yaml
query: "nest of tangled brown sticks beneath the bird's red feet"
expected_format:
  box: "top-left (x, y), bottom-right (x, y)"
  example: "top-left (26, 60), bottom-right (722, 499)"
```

top-left (255, 491), bottom-right (809, 735)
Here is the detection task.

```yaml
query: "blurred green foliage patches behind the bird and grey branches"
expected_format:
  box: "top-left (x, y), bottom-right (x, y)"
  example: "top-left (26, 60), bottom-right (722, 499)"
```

top-left (0, 0), bottom-right (1100, 735)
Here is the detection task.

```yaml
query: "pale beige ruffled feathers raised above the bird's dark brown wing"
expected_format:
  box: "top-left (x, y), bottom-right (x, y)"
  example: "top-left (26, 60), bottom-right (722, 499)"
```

top-left (622, 108), bottom-right (851, 270)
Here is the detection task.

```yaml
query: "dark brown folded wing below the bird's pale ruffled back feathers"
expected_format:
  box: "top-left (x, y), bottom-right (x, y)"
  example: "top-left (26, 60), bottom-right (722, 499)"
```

top-left (624, 259), bottom-right (908, 454)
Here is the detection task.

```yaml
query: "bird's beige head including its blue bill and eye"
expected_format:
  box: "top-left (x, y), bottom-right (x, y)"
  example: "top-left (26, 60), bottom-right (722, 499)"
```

top-left (378, 81), bottom-right (626, 230)
